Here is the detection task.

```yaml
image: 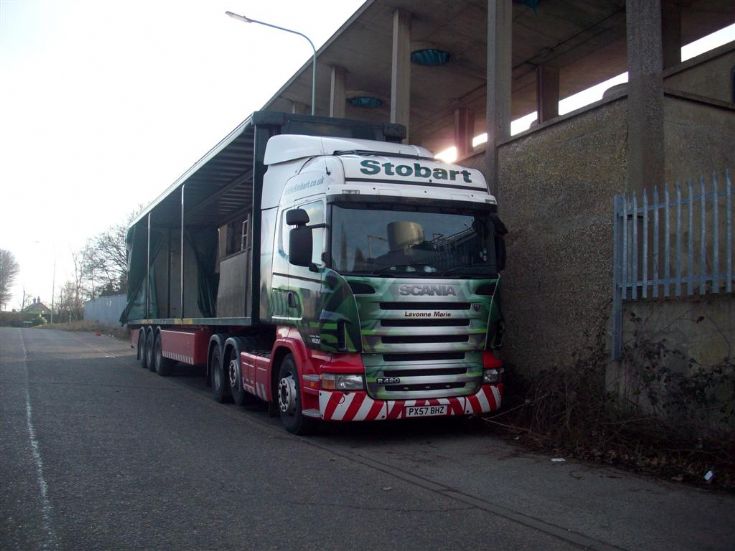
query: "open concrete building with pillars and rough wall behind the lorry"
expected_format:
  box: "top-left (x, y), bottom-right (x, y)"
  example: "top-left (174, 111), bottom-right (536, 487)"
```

top-left (256, 0), bottom-right (735, 390)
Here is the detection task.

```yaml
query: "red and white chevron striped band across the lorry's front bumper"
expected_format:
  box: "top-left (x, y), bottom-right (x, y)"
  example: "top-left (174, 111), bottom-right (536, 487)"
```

top-left (319, 385), bottom-right (502, 421)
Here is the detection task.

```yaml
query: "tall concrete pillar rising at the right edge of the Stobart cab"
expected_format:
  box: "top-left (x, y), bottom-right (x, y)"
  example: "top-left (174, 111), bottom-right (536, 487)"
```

top-left (485, 0), bottom-right (513, 196)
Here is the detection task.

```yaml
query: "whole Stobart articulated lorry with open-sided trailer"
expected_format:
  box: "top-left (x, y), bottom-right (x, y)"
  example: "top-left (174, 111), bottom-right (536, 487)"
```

top-left (121, 111), bottom-right (506, 434)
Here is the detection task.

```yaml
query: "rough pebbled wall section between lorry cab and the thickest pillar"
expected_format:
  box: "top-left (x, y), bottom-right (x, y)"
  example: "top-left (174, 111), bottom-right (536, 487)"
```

top-left (498, 99), bottom-right (626, 376)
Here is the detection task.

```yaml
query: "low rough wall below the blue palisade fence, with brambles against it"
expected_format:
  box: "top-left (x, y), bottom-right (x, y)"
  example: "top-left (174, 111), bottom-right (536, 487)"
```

top-left (607, 294), bottom-right (735, 436)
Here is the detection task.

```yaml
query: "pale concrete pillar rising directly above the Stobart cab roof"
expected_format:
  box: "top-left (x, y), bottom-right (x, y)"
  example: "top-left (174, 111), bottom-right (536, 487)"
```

top-left (390, 10), bottom-right (411, 141)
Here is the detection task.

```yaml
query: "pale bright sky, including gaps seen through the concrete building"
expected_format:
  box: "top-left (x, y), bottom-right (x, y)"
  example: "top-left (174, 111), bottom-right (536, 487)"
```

top-left (0, 0), bottom-right (735, 309)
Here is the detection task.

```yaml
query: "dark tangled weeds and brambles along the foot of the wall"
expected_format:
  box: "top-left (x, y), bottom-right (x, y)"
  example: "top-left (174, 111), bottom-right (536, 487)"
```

top-left (488, 302), bottom-right (735, 489)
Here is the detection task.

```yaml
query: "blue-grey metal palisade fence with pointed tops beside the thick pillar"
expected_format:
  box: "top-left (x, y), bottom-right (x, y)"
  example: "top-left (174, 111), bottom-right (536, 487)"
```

top-left (612, 172), bottom-right (733, 360)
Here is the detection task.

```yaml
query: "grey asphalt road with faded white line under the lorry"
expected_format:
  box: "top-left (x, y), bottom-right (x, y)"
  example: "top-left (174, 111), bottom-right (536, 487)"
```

top-left (0, 328), bottom-right (735, 551)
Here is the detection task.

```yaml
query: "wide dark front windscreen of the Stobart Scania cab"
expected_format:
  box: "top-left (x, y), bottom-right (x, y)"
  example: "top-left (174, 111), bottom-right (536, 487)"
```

top-left (330, 204), bottom-right (498, 277)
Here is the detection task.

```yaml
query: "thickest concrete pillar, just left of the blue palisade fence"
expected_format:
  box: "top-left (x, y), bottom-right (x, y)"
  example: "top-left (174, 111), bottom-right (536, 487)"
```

top-left (626, 0), bottom-right (664, 191)
